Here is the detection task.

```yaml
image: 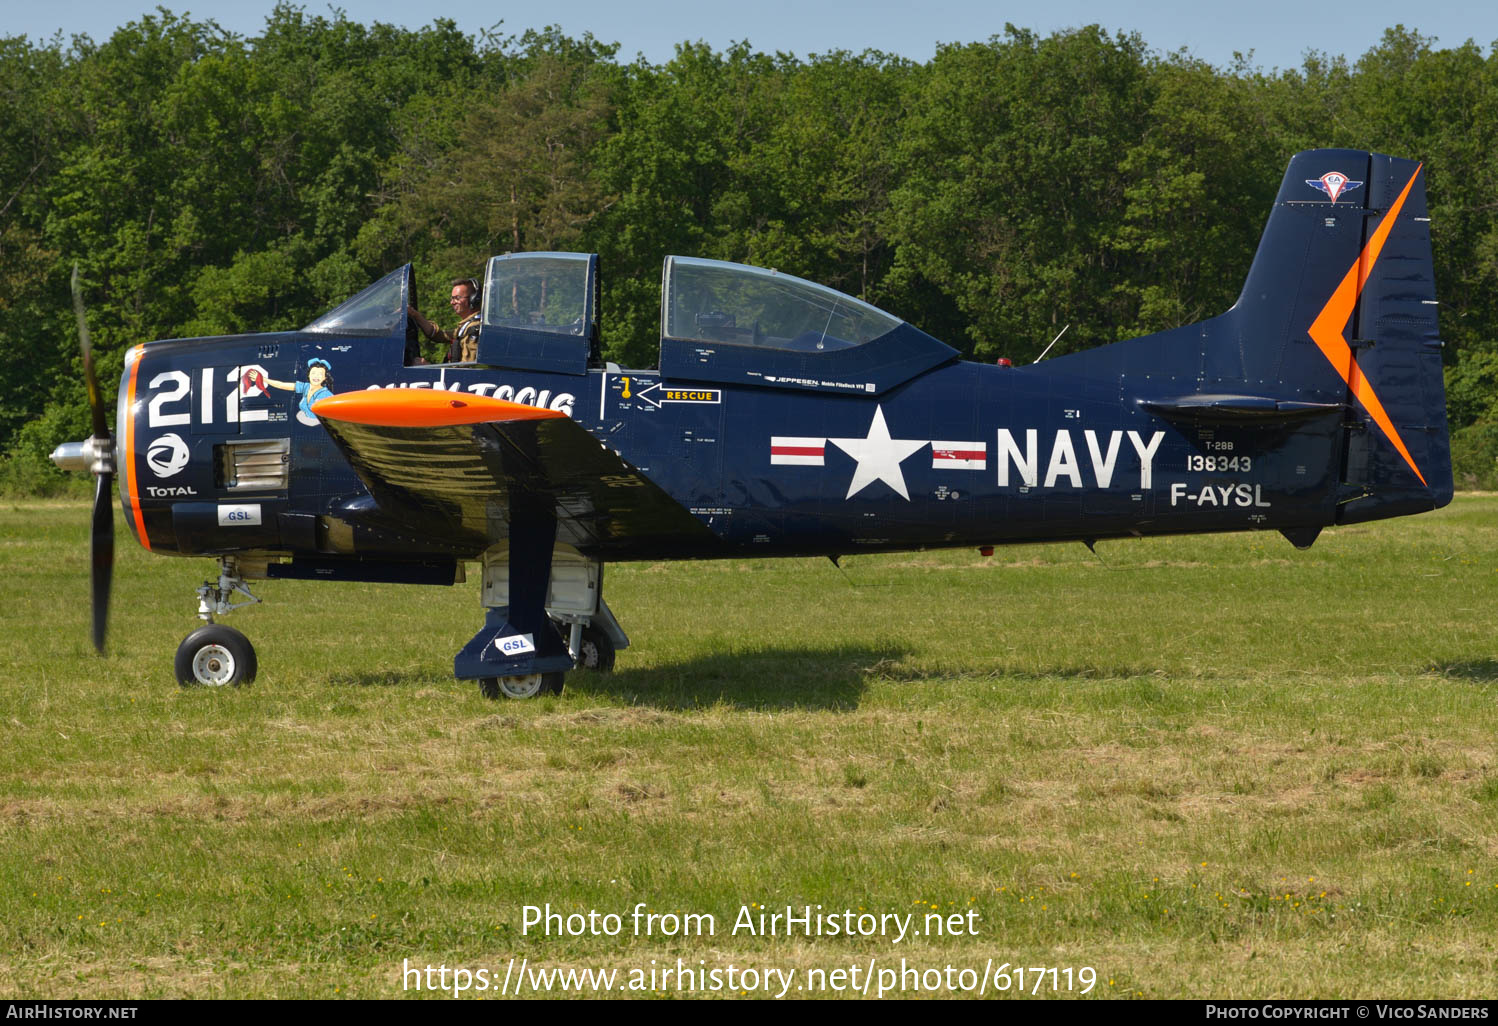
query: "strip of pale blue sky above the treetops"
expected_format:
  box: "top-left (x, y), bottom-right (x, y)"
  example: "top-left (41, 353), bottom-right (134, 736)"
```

top-left (11, 0), bottom-right (1498, 69)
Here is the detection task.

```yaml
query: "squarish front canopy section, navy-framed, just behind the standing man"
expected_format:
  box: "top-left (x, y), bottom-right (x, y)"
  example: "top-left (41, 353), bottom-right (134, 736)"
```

top-left (478, 253), bottom-right (598, 374)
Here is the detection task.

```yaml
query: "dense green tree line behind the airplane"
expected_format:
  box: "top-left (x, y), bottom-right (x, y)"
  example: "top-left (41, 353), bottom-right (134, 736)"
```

top-left (0, 3), bottom-right (1498, 491)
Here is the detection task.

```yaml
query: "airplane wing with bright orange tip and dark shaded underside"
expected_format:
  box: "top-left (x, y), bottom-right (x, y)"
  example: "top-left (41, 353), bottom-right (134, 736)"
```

top-left (313, 388), bottom-right (716, 559)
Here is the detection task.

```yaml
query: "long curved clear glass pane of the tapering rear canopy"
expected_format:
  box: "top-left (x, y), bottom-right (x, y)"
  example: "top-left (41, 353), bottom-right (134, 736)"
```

top-left (661, 256), bottom-right (900, 352)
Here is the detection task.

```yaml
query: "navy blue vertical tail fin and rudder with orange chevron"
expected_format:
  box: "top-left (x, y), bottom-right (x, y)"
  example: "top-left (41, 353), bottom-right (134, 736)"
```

top-left (1228, 150), bottom-right (1452, 523)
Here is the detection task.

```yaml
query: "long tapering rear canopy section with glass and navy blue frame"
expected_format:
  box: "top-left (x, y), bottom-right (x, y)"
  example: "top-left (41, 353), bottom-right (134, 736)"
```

top-left (661, 256), bottom-right (957, 395)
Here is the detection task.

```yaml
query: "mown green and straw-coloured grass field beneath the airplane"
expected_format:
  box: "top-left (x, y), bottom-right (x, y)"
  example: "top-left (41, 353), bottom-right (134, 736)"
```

top-left (0, 496), bottom-right (1498, 999)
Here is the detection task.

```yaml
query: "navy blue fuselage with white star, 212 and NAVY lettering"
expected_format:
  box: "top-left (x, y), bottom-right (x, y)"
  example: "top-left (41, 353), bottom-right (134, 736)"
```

top-left (120, 333), bottom-right (1342, 559)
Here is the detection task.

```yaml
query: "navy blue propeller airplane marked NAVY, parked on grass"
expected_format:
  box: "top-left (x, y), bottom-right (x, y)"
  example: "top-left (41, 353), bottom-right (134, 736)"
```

top-left (52, 150), bottom-right (1452, 698)
